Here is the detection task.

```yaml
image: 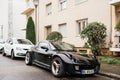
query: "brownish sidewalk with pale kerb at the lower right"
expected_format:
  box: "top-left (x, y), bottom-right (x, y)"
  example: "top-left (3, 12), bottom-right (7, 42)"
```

top-left (99, 62), bottom-right (120, 80)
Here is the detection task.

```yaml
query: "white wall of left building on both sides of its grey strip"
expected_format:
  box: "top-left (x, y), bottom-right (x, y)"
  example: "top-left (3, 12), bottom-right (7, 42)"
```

top-left (0, 0), bottom-right (26, 39)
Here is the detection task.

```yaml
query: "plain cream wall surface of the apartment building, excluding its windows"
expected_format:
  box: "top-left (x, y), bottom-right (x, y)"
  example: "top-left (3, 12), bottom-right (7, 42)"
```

top-left (39, 0), bottom-right (111, 47)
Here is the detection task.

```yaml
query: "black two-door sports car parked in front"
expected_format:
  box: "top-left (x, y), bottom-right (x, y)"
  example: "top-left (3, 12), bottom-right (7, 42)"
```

top-left (25, 41), bottom-right (100, 77)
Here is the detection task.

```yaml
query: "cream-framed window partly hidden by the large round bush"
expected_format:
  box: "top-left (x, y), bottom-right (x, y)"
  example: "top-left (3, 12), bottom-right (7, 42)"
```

top-left (77, 19), bottom-right (88, 35)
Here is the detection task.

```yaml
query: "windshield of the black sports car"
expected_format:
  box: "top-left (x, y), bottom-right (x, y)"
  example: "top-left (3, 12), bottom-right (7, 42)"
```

top-left (52, 42), bottom-right (75, 51)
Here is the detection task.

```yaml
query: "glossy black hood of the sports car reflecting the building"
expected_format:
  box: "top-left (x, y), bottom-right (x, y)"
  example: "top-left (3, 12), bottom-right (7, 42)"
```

top-left (60, 51), bottom-right (96, 65)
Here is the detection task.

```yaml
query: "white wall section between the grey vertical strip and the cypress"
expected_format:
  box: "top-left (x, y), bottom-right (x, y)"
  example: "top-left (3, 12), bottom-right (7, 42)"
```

top-left (13, 0), bottom-right (26, 38)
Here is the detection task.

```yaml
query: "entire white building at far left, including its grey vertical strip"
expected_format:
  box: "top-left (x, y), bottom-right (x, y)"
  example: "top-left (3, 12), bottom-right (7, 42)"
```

top-left (0, 0), bottom-right (26, 39)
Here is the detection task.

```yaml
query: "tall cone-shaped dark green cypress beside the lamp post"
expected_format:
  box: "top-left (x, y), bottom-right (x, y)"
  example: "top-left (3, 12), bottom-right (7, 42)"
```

top-left (26, 17), bottom-right (36, 44)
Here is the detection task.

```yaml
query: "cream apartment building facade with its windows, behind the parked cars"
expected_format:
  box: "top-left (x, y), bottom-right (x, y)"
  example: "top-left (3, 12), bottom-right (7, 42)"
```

top-left (23, 0), bottom-right (120, 48)
